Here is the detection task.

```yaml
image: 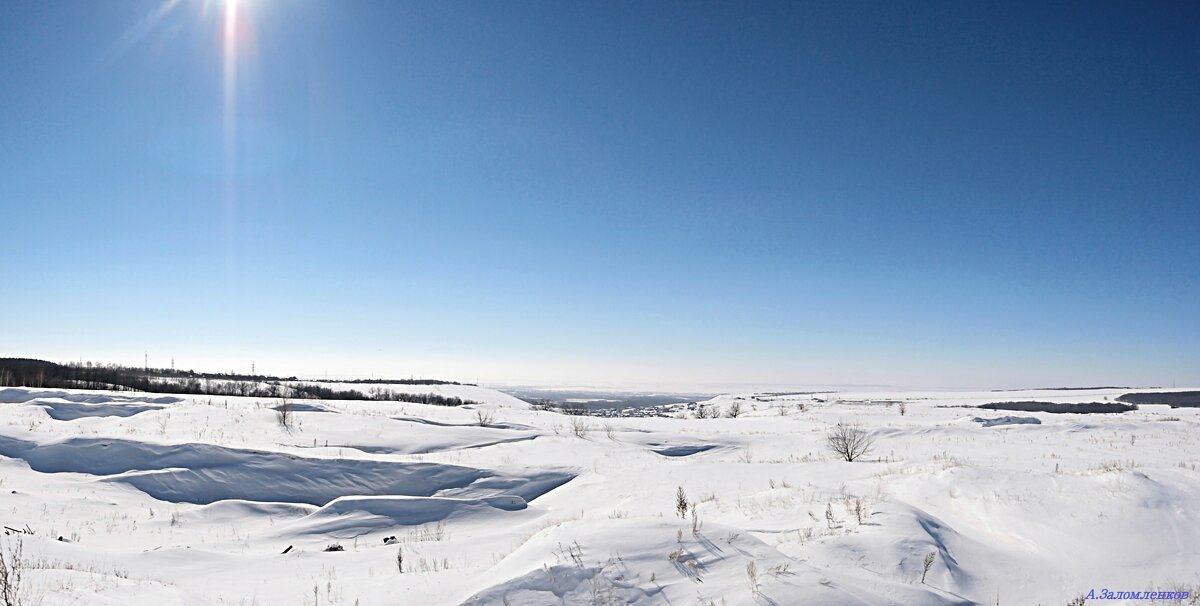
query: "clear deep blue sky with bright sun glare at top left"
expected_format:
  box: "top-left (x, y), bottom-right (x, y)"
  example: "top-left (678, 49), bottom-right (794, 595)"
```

top-left (0, 0), bottom-right (1200, 389)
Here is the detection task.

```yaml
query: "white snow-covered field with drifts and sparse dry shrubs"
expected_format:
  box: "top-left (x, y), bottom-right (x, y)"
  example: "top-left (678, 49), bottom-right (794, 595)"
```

top-left (0, 385), bottom-right (1200, 606)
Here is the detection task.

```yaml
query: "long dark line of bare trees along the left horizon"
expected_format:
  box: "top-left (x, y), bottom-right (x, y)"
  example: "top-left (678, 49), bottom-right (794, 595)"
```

top-left (0, 358), bottom-right (478, 406)
